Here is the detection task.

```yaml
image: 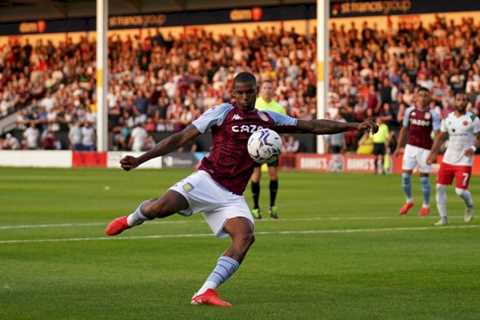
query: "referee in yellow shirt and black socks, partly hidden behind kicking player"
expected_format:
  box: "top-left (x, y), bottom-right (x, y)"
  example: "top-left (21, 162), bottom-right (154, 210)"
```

top-left (251, 80), bottom-right (287, 219)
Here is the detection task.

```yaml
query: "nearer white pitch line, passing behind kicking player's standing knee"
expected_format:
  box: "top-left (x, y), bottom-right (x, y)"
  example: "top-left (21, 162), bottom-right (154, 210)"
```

top-left (0, 225), bottom-right (480, 245)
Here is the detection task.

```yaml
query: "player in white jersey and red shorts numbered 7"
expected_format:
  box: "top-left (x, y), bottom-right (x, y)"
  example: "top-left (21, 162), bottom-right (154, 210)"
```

top-left (427, 93), bottom-right (480, 226)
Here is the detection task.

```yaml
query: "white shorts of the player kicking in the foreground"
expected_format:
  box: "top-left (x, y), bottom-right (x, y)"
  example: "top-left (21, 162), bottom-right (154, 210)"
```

top-left (170, 170), bottom-right (255, 238)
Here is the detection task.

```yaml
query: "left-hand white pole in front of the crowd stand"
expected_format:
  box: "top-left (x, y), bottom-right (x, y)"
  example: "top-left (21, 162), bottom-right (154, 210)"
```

top-left (96, 0), bottom-right (108, 151)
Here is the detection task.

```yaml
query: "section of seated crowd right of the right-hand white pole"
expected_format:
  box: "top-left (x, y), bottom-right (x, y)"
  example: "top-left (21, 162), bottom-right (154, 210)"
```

top-left (327, 16), bottom-right (480, 153)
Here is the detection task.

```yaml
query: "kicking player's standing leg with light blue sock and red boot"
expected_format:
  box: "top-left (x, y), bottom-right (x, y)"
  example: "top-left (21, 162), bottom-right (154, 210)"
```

top-left (192, 217), bottom-right (255, 307)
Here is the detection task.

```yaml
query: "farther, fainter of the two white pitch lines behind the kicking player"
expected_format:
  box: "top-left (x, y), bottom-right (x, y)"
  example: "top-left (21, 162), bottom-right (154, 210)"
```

top-left (0, 216), bottom-right (470, 230)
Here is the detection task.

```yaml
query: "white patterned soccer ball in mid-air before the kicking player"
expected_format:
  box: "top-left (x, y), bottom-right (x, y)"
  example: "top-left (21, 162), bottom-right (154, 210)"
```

top-left (247, 129), bottom-right (282, 163)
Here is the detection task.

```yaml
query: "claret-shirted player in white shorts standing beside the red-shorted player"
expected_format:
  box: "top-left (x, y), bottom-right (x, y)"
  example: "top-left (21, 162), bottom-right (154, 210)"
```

top-left (395, 87), bottom-right (440, 216)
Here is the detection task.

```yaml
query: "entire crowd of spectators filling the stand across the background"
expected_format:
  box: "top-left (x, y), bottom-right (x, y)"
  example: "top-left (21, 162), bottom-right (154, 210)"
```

top-left (0, 17), bottom-right (480, 151)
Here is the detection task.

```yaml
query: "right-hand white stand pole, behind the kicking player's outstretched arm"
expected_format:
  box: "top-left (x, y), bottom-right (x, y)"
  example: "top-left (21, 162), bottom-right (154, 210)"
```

top-left (317, 0), bottom-right (330, 153)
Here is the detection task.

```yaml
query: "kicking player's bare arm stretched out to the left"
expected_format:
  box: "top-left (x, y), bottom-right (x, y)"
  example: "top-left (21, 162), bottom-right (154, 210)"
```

top-left (120, 125), bottom-right (201, 171)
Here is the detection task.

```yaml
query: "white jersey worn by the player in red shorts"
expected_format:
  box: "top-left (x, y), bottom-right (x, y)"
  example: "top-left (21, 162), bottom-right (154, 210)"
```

top-left (440, 112), bottom-right (480, 166)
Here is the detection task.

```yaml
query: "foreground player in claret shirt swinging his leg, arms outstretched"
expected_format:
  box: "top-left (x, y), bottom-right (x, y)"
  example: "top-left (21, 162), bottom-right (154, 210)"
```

top-left (105, 72), bottom-right (376, 307)
